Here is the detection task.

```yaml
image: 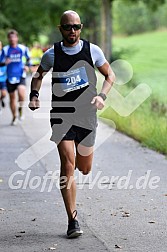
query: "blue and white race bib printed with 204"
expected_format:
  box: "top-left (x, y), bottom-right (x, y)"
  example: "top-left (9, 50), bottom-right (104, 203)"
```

top-left (54, 67), bottom-right (89, 93)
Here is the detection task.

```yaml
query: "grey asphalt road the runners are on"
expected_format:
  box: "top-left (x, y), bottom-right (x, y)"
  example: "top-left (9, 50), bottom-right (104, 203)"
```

top-left (0, 74), bottom-right (167, 252)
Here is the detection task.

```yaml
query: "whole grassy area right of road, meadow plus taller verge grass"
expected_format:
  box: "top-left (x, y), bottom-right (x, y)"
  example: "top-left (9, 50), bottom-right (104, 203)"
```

top-left (96, 31), bottom-right (167, 154)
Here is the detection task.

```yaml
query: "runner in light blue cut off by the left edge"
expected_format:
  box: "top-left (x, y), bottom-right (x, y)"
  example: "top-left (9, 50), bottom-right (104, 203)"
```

top-left (0, 41), bottom-right (6, 112)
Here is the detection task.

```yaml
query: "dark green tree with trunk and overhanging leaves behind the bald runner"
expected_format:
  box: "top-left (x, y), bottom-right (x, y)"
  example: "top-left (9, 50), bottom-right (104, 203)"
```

top-left (0, 0), bottom-right (165, 52)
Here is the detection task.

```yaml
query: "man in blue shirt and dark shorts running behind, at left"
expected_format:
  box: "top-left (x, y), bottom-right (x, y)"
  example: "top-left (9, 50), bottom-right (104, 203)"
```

top-left (0, 30), bottom-right (30, 125)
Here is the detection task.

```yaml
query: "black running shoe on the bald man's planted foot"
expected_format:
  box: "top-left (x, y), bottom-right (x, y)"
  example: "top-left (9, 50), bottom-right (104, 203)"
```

top-left (67, 210), bottom-right (83, 238)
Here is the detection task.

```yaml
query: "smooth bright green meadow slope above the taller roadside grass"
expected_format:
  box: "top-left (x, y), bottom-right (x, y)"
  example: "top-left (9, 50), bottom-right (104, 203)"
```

top-left (113, 31), bottom-right (167, 102)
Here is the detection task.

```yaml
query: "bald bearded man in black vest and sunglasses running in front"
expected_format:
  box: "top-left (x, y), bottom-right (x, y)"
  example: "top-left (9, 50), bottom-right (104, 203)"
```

top-left (29, 10), bottom-right (114, 238)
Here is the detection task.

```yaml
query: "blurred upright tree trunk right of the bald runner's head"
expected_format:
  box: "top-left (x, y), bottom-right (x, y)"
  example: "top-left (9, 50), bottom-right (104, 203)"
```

top-left (101, 0), bottom-right (113, 62)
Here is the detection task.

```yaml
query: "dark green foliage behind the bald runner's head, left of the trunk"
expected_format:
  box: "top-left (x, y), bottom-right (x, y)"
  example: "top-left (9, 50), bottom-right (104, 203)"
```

top-left (0, 0), bottom-right (100, 44)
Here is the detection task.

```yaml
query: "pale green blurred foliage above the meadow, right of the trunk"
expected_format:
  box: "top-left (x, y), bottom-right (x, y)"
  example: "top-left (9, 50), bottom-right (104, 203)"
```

top-left (113, 0), bottom-right (167, 35)
